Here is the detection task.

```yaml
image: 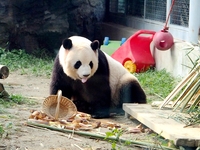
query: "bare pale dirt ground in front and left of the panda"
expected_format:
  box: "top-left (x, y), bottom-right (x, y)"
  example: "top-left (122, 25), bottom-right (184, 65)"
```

top-left (0, 73), bottom-right (152, 150)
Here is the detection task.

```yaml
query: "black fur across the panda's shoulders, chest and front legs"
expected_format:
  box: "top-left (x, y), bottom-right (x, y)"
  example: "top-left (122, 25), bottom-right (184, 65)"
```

top-left (50, 47), bottom-right (111, 118)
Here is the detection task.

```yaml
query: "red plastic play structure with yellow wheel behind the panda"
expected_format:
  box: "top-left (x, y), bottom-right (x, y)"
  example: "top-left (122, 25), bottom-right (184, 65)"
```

top-left (111, 30), bottom-right (156, 73)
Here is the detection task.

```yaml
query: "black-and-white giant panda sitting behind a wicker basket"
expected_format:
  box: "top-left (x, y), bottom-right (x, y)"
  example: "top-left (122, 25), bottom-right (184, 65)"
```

top-left (50, 36), bottom-right (146, 118)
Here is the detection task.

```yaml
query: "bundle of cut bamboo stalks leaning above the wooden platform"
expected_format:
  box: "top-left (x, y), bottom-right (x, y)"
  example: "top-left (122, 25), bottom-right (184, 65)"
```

top-left (159, 61), bottom-right (200, 113)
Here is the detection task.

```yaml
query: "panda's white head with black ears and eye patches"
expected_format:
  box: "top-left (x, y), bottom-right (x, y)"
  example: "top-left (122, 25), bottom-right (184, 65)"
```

top-left (59, 36), bottom-right (99, 83)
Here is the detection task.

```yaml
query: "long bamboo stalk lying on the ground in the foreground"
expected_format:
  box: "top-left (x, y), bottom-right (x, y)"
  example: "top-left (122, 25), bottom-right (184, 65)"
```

top-left (27, 121), bottom-right (177, 150)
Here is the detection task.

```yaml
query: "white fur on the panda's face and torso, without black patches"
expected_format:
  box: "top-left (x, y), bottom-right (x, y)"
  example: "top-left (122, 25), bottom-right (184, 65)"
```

top-left (59, 36), bottom-right (137, 105)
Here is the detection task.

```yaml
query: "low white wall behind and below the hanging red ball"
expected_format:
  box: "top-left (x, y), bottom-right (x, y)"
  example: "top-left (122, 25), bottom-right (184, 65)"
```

top-left (154, 39), bottom-right (200, 77)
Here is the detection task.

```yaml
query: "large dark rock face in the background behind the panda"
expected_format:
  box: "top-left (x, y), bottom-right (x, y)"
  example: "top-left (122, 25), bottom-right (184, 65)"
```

top-left (0, 0), bottom-right (106, 53)
